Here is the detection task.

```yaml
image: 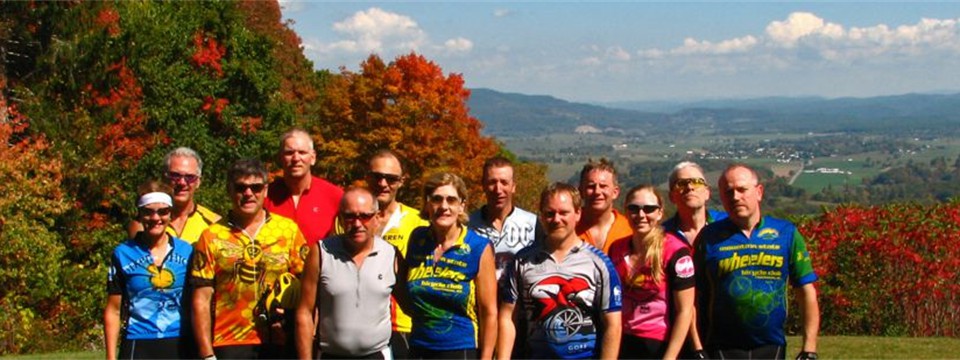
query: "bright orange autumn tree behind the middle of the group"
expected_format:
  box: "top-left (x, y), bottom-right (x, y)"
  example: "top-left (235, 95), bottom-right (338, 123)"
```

top-left (312, 53), bottom-right (499, 207)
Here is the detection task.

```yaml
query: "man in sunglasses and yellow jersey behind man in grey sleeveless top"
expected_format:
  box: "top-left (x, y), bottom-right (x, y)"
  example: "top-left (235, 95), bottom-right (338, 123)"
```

top-left (358, 150), bottom-right (429, 359)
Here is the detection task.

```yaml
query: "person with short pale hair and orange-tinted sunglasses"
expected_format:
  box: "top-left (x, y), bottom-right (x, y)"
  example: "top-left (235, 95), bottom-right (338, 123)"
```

top-left (663, 161), bottom-right (727, 248)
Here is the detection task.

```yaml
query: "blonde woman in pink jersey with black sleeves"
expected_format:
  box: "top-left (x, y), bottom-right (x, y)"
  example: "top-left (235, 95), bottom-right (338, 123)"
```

top-left (610, 185), bottom-right (694, 359)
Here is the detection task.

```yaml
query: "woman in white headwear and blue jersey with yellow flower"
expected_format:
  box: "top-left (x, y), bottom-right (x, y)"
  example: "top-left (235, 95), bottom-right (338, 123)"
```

top-left (103, 181), bottom-right (196, 360)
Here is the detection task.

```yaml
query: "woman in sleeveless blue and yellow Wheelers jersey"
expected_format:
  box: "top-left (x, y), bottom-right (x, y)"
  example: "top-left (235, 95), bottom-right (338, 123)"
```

top-left (406, 173), bottom-right (497, 359)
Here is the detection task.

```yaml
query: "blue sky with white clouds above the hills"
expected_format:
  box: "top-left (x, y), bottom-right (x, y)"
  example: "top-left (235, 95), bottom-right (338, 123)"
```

top-left (281, 0), bottom-right (960, 102)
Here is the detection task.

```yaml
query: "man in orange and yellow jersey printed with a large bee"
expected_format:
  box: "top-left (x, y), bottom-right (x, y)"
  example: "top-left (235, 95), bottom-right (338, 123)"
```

top-left (190, 159), bottom-right (308, 359)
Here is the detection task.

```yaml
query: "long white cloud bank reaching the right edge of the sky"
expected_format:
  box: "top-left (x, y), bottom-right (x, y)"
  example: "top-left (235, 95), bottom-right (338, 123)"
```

top-left (636, 12), bottom-right (960, 71)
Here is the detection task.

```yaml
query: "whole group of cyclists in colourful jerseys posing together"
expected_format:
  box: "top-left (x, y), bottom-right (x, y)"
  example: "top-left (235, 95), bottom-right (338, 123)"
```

top-left (104, 129), bottom-right (819, 359)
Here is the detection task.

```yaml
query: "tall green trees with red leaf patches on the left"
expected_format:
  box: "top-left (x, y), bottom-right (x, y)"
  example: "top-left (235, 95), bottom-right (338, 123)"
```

top-left (0, 1), bottom-right (321, 353)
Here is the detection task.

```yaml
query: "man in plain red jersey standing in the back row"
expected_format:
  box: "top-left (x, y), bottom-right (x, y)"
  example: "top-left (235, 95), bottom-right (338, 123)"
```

top-left (264, 129), bottom-right (343, 244)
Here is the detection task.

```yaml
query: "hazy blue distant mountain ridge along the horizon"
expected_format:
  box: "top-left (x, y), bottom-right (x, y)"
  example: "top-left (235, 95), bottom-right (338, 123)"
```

top-left (468, 89), bottom-right (960, 136)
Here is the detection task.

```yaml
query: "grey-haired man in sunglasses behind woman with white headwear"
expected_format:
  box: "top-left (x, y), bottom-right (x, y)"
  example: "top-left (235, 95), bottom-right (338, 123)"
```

top-left (127, 147), bottom-right (220, 244)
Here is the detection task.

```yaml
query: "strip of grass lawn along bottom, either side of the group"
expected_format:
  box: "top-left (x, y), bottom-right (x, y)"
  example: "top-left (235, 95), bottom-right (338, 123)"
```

top-left (7, 336), bottom-right (960, 360)
